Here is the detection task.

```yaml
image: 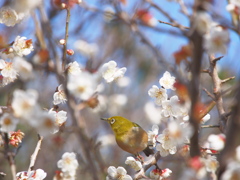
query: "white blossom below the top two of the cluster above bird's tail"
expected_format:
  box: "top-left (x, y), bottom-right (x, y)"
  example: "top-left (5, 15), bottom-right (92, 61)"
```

top-left (162, 96), bottom-right (180, 117)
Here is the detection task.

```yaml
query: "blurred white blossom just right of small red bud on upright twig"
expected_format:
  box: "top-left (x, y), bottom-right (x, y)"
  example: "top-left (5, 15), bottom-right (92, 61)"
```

top-left (74, 40), bottom-right (98, 58)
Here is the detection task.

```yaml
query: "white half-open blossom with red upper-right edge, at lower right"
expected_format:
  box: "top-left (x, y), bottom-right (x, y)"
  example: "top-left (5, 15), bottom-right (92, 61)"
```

top-left (208, 134), bottom-right (226, 151)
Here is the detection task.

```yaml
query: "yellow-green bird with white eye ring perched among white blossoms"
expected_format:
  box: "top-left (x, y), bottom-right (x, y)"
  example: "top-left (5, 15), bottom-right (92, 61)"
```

top-left (101, 116), bottom-right (153, 156)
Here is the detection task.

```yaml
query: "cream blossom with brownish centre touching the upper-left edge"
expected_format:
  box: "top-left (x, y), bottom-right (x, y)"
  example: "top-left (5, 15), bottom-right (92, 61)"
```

top-left (0, 7), bottom-right (19, 26)
